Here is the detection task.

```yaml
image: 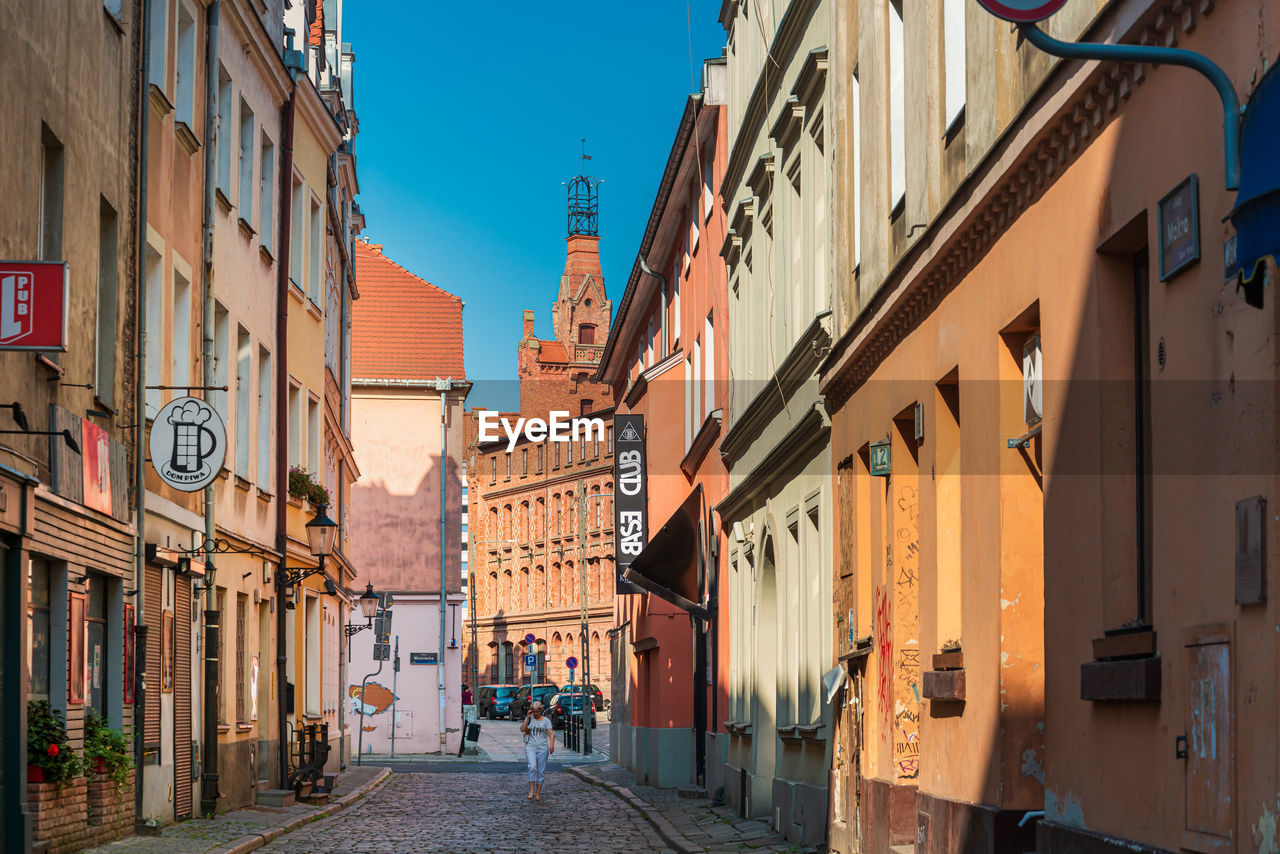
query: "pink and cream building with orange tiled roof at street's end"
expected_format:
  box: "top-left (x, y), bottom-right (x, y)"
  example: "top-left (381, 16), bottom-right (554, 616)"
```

top-left (344, 242), bottom-right (471, 754)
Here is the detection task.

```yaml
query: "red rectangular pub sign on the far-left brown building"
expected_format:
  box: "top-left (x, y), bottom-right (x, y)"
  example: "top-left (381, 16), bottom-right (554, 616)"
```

top-left (0, 261), bottom-right (69, 350)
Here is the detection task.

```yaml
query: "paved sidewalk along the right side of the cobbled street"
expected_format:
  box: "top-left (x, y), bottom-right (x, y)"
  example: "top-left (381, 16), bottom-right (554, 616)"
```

top-left (585, 763), bottom-right (823, 854)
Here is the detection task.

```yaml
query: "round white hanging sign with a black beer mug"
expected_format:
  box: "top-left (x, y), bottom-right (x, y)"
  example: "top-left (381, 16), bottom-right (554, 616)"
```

top-left (150, 397), bottom-right (227, 492)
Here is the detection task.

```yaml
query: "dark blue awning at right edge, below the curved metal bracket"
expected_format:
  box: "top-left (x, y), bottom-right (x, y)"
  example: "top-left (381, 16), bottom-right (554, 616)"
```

top-left (1230, 61), bottom-right (1280, 307)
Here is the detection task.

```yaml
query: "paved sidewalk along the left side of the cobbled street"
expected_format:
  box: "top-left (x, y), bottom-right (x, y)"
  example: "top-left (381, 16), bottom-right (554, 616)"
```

top-left (84, 764), bottom-right (390, 854)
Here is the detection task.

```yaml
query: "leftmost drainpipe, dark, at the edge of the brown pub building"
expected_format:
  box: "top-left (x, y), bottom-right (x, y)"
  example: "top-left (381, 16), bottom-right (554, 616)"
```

top-left (133, 0), bottom-right (151, 822)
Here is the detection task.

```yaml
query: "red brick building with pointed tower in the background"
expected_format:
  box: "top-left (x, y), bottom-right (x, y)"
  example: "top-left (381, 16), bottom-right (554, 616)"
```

top-left (465, 197), bottom-right (614, 697)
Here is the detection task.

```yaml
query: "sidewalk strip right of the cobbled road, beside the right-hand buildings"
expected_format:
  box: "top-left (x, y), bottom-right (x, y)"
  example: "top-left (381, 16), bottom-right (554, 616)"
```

top-left (567, 763), bottom-right (820, 854)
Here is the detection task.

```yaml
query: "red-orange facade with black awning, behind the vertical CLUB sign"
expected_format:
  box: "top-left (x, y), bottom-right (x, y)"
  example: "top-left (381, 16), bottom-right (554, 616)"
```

top-left (598, 60), bottom-right (733, 793)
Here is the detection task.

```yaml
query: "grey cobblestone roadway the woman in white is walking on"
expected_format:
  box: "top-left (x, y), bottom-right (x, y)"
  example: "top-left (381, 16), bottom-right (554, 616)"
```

top-left (252, 769), bottom-right (669, 854)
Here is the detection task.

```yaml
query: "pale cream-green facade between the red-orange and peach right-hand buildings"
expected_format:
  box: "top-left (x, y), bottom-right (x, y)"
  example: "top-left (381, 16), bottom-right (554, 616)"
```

top-left (716, 0), bottom-right (840, 844)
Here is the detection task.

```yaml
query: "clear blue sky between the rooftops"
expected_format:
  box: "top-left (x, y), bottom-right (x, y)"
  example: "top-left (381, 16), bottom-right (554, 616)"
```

top-left (343, 0), bottom-right (724, 408)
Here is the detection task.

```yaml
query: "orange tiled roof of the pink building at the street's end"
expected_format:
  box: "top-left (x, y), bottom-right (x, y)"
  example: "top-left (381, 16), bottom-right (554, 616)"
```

top-left (351, 241), bottom-right (466, 379)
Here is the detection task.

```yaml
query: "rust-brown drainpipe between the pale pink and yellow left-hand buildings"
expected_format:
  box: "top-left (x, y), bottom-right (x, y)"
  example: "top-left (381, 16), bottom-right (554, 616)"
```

top-left (275, 73), bottom-right (301, 789)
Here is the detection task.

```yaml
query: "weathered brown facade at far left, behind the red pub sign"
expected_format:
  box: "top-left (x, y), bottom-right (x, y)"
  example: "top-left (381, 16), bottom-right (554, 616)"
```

top-left (0, 1), bottom-right (141, 850)
